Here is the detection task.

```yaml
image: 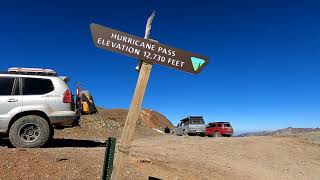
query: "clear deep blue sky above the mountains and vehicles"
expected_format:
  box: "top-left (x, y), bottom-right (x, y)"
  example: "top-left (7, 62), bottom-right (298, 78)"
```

top-left (0, 0), bottom-right (320, 131)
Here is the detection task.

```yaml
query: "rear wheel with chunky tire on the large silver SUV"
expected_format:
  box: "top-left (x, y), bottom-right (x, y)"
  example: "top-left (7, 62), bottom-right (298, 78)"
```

top-left (9, 115), bottom-right (51, 148)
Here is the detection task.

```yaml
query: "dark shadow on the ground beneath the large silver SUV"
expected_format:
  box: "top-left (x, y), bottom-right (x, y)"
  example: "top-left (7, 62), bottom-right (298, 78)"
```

top-left (0, 138), bottom-right (106, 148)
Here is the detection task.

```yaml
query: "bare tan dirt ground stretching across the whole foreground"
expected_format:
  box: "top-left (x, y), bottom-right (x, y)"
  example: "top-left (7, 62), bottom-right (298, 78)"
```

top-left (0, 135), bottom-right (320, 180)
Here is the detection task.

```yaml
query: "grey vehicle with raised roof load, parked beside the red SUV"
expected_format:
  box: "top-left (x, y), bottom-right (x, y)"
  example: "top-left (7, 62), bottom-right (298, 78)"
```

top-left (175, 116), bottom-right (206, 136)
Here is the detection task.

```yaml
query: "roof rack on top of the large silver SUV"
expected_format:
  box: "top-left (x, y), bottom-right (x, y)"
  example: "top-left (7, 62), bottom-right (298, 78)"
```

top-left (8, 67), bottom-right (58, 76)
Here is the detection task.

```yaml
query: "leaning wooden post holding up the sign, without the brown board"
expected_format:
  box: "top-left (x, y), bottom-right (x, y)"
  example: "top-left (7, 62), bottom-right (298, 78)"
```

top-left (111, 12), bottom-right (155, 180)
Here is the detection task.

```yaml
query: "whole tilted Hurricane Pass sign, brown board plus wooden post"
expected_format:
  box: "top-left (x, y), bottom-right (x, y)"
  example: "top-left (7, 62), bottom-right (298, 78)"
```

top-left (90, 12), bottom-right (209, 180)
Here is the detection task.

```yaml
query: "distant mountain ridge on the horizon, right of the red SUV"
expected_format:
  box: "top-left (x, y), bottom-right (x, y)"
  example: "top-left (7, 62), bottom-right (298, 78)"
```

top-left (238, 127), bottom-right (320, 137)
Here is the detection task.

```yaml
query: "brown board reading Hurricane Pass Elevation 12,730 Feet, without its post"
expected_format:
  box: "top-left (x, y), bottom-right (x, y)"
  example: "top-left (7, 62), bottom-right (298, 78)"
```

top-left (90, 23), bottom-right (208, 74)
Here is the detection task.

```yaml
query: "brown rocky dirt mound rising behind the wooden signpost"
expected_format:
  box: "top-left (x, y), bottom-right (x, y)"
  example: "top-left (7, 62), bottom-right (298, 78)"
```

top-left (56, 108), bottom-right (173, 139)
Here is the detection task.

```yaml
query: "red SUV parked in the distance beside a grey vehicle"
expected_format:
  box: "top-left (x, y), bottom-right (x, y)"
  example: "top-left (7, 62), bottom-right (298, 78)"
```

top-left (206, 122), bottom-right (233, 137)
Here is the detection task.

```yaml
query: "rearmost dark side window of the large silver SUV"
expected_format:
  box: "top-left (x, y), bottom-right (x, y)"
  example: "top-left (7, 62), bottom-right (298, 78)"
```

top-left (23, 78), bottom-right (54, 95)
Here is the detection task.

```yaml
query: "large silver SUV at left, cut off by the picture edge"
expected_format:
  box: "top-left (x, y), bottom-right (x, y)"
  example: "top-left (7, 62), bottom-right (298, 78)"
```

top-left (0, 68), bottom-right (78, 147)
